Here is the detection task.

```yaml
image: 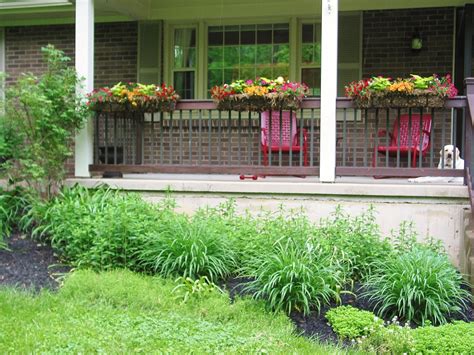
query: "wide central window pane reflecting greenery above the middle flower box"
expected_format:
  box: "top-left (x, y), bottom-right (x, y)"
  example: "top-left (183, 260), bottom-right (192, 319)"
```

top-left (207, 23), bottom-right (290, 89)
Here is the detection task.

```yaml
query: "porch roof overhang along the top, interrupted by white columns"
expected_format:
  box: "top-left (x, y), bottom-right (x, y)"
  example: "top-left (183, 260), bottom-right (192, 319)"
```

top-left (0, 0), bottom-right (470, 26)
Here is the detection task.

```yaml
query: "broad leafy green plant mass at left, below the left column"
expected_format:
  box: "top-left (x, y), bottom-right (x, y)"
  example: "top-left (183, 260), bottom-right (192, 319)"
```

top-left (30, 186), bottom-right (166, 270)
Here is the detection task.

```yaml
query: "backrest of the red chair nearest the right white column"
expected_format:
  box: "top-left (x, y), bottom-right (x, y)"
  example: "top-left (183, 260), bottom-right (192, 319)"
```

top-left (261, 111), bottom-right (298, 148)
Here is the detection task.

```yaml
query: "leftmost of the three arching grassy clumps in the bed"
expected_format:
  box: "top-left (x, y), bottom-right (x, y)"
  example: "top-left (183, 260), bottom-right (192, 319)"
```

top-left (137, 212), bottom-right (236, 282)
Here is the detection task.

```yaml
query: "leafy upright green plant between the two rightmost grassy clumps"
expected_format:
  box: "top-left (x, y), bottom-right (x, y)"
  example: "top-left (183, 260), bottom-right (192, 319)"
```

top-left (318, 207), bottom-right (392, 280)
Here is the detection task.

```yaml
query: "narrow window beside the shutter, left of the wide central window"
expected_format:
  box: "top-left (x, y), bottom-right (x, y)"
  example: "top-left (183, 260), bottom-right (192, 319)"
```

top-left (172, 28), bottom-right (196, 99)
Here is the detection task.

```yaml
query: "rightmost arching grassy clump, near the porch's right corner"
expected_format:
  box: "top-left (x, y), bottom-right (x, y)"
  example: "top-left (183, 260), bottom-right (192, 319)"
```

top-left (364, 248), bottom-right (469, 324)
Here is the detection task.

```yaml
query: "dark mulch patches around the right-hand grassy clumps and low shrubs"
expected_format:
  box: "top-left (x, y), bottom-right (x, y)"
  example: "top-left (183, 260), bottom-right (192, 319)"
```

top-left (226, 278), bottom-right (474, 345)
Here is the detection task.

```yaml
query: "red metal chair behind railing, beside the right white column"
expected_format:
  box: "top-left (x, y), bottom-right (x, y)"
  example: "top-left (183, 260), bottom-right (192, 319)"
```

top-left (261, 111), bottom-right (309, 166)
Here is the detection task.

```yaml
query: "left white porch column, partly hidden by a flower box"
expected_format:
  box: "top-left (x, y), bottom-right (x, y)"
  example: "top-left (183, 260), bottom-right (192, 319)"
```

top-left (74, 0), bottom-right (94, 177)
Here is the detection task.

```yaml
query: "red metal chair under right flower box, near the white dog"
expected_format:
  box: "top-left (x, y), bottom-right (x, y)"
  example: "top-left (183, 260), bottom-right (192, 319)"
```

top-left (372, 114), bottom-right (432, 168)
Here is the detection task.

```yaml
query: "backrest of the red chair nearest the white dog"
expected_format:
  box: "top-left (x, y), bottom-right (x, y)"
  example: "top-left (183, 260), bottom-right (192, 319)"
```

top-left (391, 114), bottom-right (432, 151)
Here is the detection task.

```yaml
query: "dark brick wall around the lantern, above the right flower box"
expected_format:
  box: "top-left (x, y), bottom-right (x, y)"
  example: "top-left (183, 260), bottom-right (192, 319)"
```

top-left (362, 7), bottom-right (455, 77)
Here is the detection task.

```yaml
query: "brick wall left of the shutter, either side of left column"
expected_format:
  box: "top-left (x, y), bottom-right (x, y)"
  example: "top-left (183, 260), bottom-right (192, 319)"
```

top-left (5, 22), bottom-right (138, 86)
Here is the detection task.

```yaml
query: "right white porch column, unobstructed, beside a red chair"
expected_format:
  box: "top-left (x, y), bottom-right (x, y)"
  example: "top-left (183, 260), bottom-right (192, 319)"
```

top-left (319, 0), bottom-right (338, 182)
